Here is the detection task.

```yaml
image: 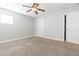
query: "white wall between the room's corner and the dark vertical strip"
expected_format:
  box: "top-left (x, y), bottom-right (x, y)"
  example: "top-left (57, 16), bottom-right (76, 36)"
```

top-left (36, 11), bottom-right (64, 41)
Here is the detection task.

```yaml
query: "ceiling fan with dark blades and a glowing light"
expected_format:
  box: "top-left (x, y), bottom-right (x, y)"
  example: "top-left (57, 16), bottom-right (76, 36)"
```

top-left (22, 3), bottom-right (45, 14)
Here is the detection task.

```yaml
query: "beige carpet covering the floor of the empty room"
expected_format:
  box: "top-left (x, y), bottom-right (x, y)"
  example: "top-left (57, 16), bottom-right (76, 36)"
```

top-left (0, 37), bottom-right (79, 56)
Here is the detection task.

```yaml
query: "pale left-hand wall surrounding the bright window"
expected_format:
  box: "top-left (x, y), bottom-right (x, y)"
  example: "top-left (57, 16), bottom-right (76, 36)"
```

top-left (0, 8), bottom-right (34, 41)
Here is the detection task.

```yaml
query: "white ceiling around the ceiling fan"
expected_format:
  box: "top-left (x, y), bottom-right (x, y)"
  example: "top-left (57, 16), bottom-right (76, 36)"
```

top-left (0, 3), bottom-right (76, 17)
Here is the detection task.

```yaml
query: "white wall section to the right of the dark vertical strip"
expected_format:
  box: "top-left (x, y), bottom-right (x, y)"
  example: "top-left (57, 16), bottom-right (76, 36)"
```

top-left (67, 7), bottom-right (79, 44)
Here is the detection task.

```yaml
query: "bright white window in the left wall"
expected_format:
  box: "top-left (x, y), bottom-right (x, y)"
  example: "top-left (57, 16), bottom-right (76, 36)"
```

top-left (1, 14), bottom-right (13, 24)
